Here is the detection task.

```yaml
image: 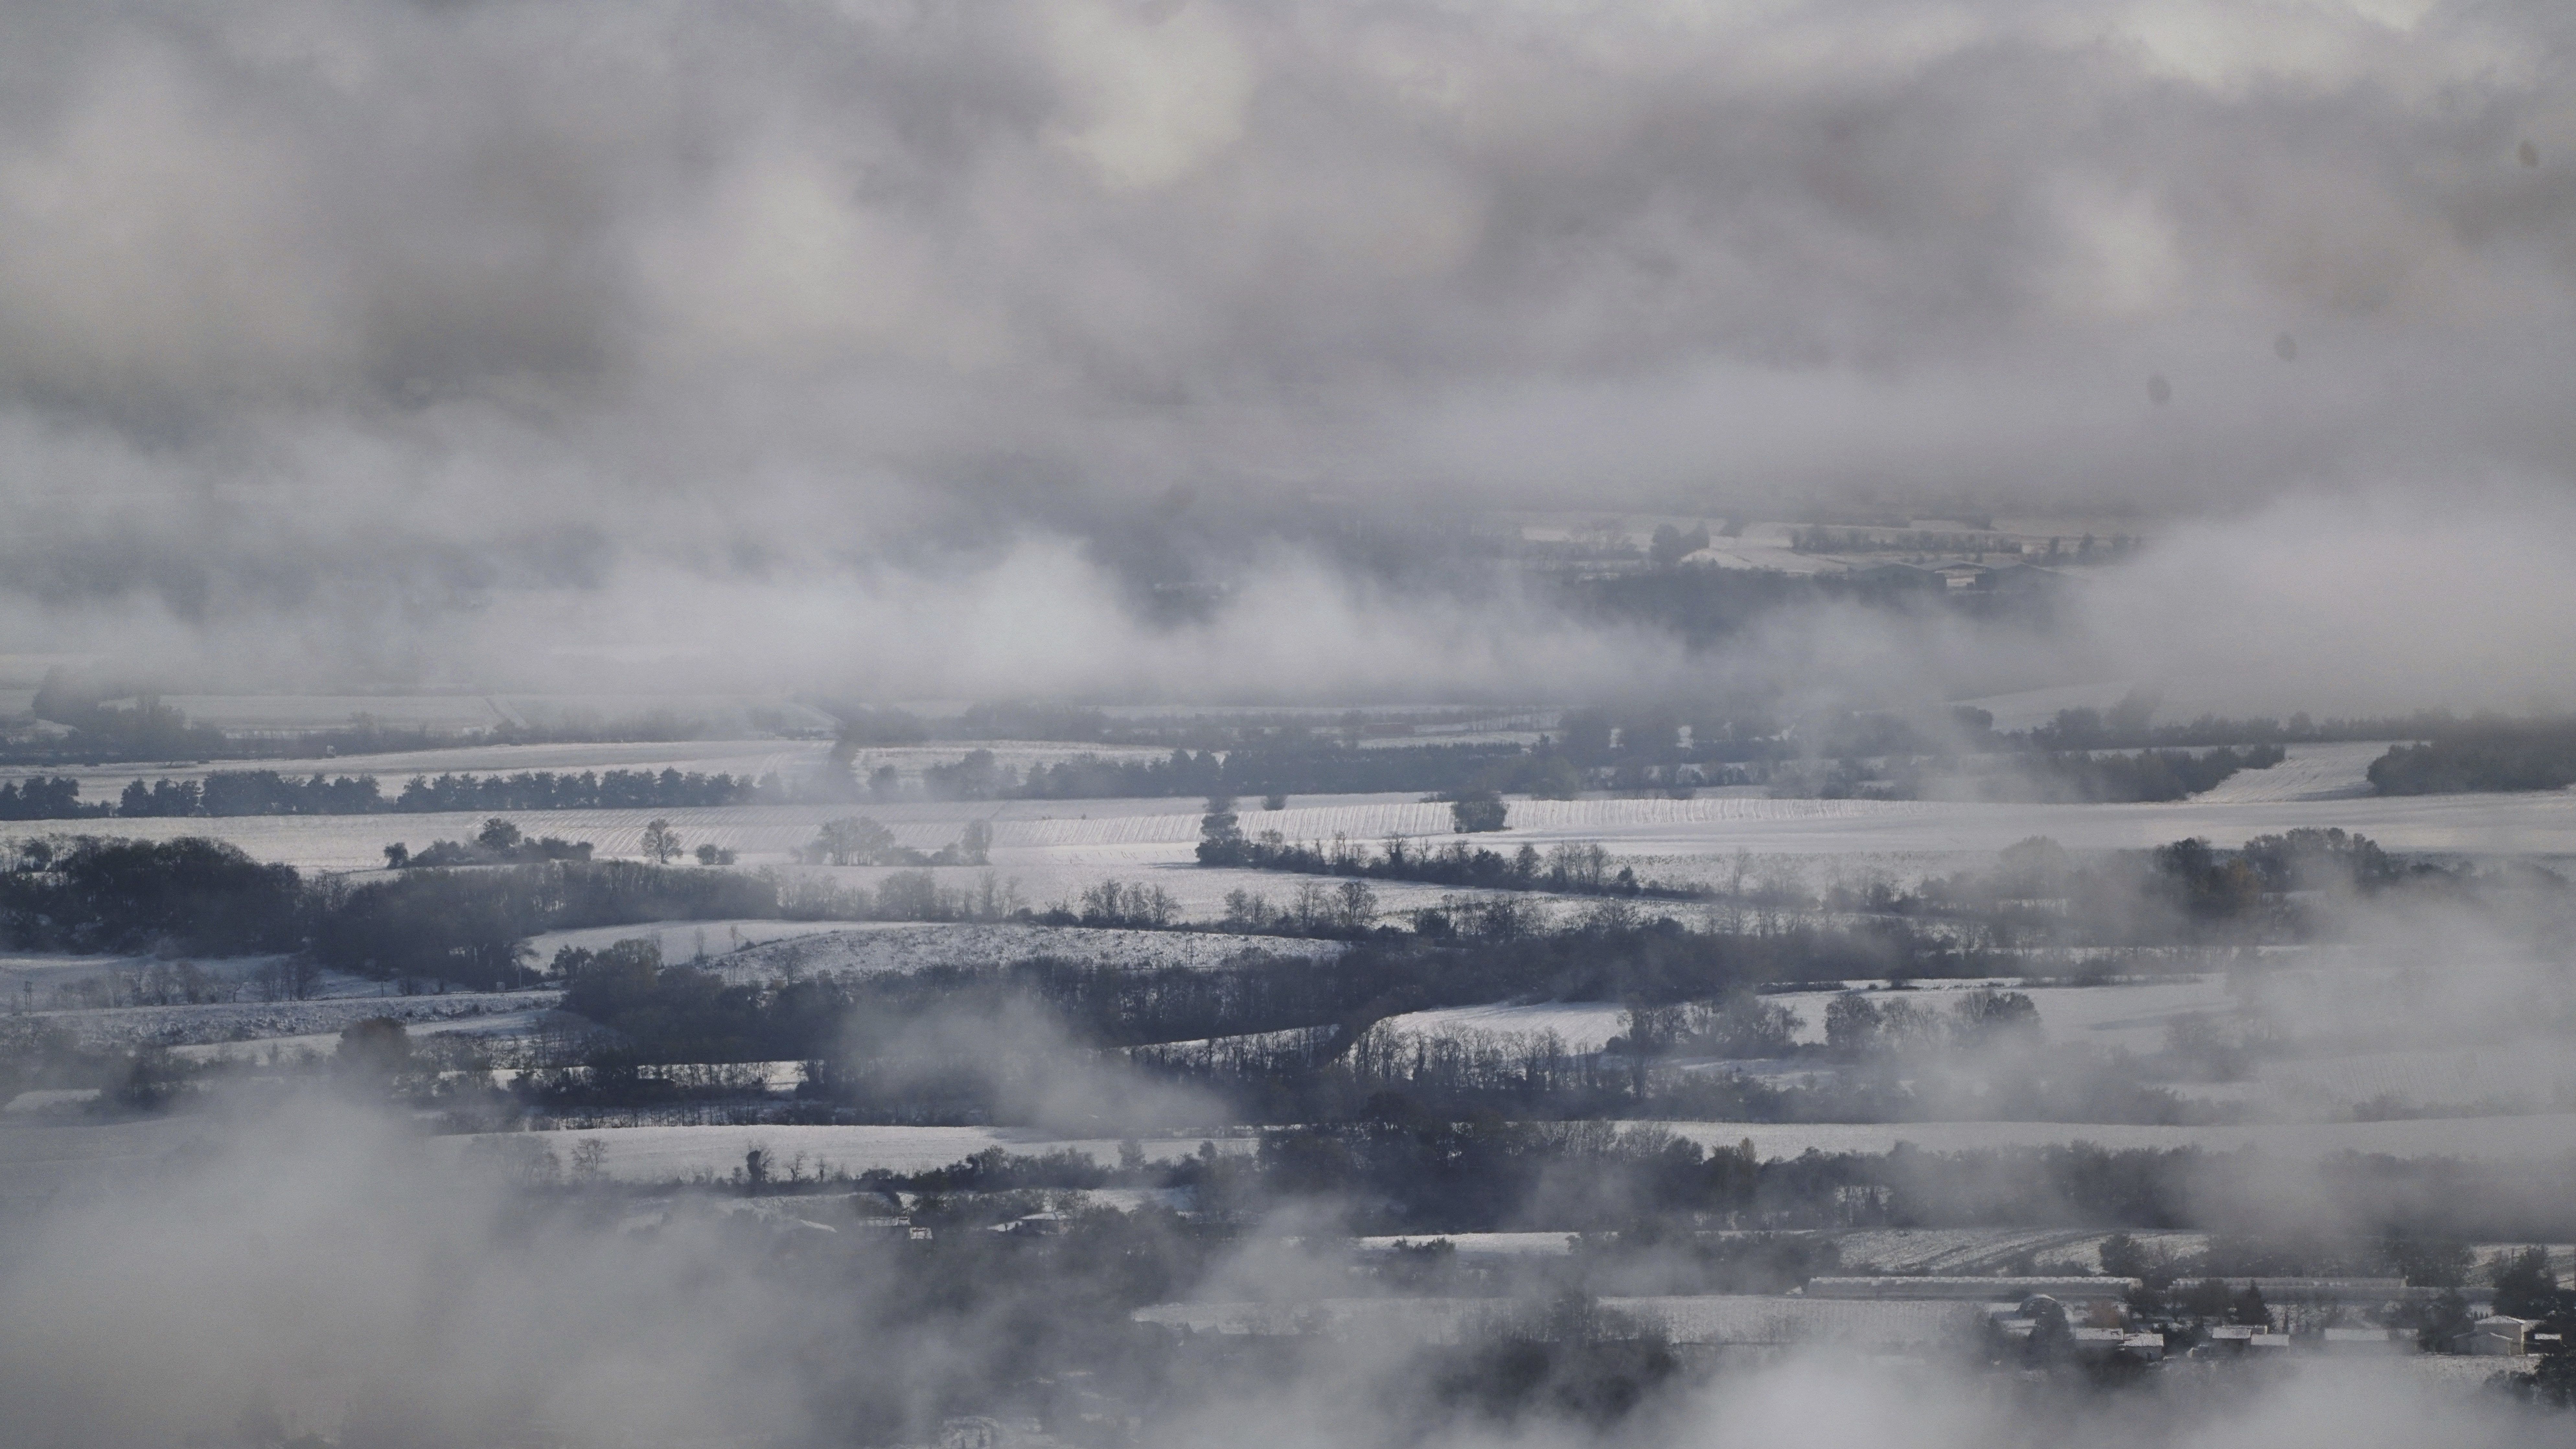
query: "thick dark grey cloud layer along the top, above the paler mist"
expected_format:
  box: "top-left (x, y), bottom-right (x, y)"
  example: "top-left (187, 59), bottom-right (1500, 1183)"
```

top-left (0, 0), bottom-right (2576, 443)
